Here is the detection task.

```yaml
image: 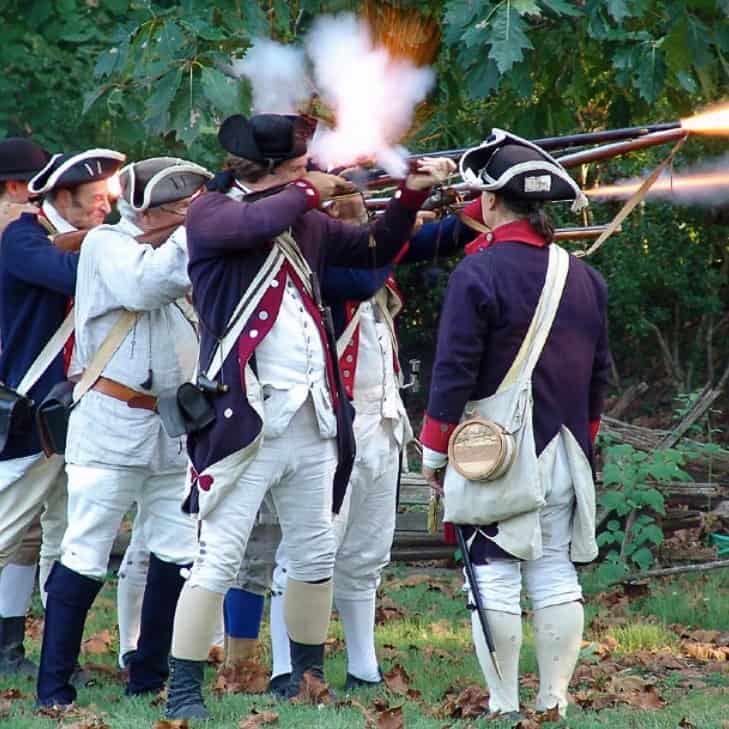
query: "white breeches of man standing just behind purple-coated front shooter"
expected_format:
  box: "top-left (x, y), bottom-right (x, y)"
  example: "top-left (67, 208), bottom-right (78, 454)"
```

top-left (334, 410), bottom-right (400, 599)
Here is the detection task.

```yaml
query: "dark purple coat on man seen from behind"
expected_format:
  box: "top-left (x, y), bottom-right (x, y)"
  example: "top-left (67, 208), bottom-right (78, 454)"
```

top-left (427, 236), bottom-right (610, 461)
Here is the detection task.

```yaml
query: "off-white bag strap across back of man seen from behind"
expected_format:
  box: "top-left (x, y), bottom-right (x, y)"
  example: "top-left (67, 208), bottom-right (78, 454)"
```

top-left (497, 243), bottom-right (570, 392)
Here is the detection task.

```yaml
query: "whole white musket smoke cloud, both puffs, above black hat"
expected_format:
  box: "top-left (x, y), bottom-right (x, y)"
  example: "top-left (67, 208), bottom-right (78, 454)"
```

top-left (233, 14), bottom-right (435, 176)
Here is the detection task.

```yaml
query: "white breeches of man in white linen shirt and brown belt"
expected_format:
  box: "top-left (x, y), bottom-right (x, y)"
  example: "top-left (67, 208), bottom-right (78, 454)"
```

top-left (61, 463), bottom-right (195, 580)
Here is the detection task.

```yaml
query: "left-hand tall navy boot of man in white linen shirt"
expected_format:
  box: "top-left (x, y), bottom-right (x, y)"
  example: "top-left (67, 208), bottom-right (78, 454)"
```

top-left (38, 562), bottom-right (102, 706)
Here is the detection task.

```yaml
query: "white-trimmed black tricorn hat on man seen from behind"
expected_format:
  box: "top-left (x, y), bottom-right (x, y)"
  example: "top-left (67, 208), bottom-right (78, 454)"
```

top-left (460, 129), bottom-right (588, 211)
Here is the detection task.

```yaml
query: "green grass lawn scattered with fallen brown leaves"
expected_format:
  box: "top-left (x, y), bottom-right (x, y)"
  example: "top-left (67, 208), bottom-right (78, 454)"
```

top-left (0, 566), bottom-right (729, 729)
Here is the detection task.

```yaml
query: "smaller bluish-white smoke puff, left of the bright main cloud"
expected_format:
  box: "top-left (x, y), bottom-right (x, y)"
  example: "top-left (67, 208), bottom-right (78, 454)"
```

top-left (231, 38), bottom-right (311, 114)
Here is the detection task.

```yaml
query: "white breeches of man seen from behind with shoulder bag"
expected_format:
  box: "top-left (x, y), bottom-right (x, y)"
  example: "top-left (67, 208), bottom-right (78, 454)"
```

top-left (475, 444), bottom-right (582, 615)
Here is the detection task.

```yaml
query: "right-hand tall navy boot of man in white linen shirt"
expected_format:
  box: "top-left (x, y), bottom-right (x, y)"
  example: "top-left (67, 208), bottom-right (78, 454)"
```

top-left (126, 554), bottom-right (189, 696)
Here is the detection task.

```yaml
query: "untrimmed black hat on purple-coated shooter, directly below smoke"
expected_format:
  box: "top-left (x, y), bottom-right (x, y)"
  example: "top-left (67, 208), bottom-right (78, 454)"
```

top-left (218, 114), bottom-right (313, 168)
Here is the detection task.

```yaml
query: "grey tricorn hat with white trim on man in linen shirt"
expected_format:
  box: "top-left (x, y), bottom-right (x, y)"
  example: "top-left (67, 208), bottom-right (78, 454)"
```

top-left (119, 157), bottom-right (213, 210)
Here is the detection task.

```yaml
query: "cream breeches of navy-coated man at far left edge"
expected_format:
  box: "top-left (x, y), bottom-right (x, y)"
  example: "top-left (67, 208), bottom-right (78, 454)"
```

top-left (0, 454), bottom-right (66, 568)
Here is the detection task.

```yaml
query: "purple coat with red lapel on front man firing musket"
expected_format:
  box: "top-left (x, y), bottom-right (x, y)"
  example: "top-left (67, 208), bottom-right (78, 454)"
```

top-left (186, 182), bottom-right (428, 511)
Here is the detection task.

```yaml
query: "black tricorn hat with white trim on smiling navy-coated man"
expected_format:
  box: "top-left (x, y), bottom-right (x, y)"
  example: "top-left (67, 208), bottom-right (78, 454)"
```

top-left (28, 149), bottom-right (126, 195)
